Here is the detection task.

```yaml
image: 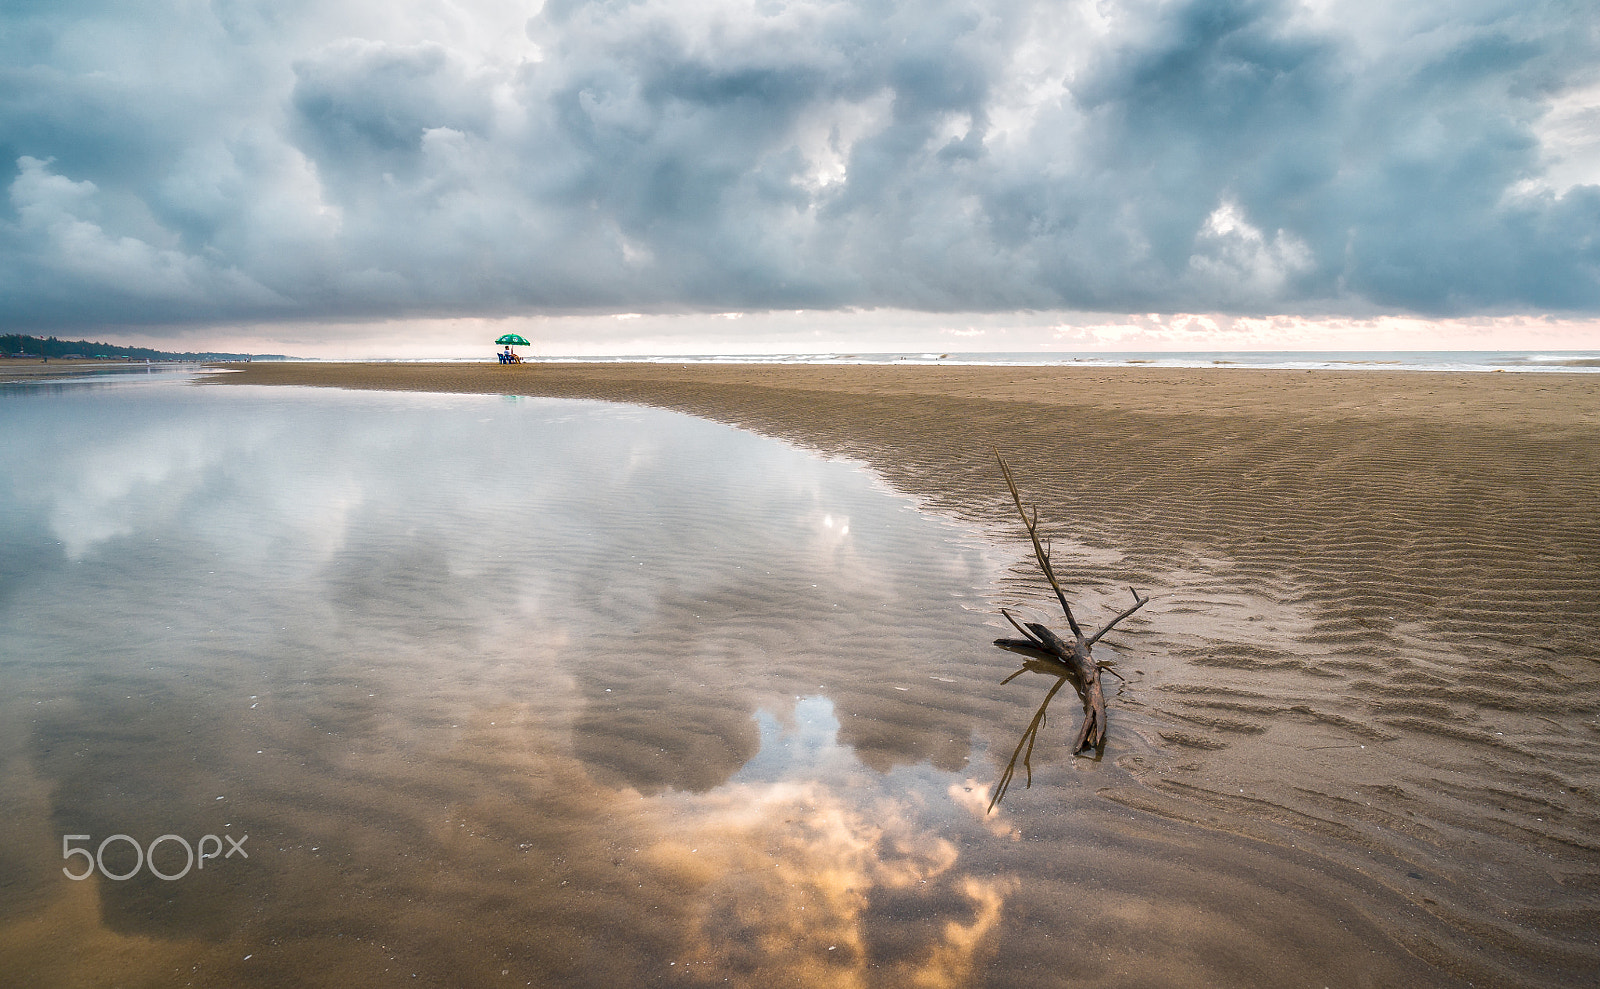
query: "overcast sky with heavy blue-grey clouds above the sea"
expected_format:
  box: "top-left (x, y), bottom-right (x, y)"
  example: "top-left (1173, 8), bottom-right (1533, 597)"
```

top-left (0, 0), bottom-right (1600, 350)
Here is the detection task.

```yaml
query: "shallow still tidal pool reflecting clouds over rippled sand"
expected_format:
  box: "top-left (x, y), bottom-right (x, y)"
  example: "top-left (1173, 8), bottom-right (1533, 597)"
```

top-left (0, 372), bottom-right (1587, 986)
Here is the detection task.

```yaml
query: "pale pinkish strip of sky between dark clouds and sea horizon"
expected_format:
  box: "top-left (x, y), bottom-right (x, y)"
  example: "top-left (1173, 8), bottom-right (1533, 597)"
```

top-left (121, 310), bottom-right (1600, 360)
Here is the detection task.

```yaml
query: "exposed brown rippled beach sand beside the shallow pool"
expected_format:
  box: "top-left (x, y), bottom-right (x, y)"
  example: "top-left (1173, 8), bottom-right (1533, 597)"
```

top-left (200, 363), bottom-right (1600, 984)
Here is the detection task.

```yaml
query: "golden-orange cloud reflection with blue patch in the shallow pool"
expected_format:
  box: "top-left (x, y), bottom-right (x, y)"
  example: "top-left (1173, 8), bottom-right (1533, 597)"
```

top-left (651, 696), bottom-right (1006, 986)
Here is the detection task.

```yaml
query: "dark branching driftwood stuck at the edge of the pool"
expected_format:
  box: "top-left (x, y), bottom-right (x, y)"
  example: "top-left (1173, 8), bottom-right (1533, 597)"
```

top-left (989, 450), bottom-right (1150, 810)
